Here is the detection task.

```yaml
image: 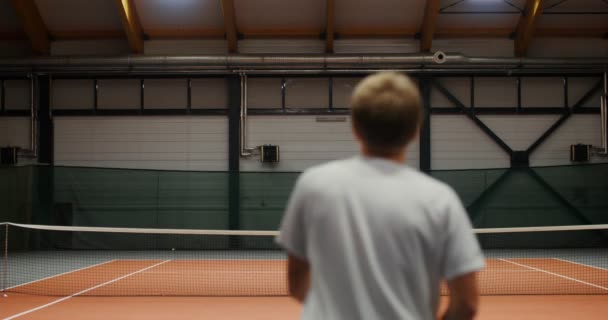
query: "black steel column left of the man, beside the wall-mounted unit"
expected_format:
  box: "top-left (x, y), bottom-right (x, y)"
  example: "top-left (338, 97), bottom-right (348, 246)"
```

top-left (226, 75), bottom-right (241, 230)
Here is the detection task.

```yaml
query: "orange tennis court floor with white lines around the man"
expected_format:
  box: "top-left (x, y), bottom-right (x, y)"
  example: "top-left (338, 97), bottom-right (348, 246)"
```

top-left (0, 258), bottom-right (608, 320)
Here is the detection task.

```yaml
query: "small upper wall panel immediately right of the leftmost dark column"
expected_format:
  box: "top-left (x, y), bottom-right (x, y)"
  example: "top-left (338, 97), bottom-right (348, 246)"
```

top-left (51, 79), bottom-right (95, 110)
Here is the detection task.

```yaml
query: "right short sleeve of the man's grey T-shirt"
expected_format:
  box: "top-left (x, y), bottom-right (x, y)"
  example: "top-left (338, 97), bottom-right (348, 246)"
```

top-left (442, 190), bottom-right (484, 280)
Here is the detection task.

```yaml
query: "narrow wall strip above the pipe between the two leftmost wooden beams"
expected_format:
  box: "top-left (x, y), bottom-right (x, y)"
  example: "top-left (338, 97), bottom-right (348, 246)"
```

top-left (51, 39), bottom-right (131, 56)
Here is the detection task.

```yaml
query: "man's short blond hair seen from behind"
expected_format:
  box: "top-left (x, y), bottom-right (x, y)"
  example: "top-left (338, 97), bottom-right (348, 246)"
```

top-left (351, 72), bottom-right (423, 156)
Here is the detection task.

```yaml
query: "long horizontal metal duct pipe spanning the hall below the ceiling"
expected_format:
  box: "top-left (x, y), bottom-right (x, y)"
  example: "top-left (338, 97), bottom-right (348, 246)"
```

top-left (0, 52), bottom-right (608, 72)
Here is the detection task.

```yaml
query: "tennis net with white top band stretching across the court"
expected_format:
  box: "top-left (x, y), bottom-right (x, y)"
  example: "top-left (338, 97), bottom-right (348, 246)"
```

top-left (0, 223), bottom-right (608, 296)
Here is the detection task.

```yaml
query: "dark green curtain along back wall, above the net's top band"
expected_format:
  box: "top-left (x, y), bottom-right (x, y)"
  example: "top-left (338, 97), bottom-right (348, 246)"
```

top-left (0, 164), bottom-right (608, 230)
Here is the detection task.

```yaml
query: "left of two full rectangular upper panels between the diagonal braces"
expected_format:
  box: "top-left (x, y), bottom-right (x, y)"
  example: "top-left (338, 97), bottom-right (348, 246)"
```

top-left (475, 77), bottom-right (517, 108)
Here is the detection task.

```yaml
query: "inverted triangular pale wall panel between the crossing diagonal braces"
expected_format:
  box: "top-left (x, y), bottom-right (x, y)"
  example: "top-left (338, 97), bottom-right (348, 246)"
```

top-left (477, 115), bottom-right (560, 151)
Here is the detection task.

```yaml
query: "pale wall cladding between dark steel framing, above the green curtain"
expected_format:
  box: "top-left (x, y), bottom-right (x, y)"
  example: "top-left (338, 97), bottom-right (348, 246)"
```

top-left (0, 69), bottom-right (605, 171)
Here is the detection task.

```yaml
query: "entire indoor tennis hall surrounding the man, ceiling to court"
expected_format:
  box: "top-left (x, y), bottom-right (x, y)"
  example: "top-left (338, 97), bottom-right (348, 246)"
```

top-left (0, 0), bottom-right (608, 320)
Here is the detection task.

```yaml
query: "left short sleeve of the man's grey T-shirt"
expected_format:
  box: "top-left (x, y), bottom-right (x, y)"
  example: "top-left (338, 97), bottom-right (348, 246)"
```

top-left (276, 175), bottom-right (308, 259)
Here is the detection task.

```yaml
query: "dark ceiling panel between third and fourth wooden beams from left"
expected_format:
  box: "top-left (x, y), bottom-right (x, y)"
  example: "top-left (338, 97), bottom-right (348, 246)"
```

top-left (234, 0), bottom-right (326, 32)
